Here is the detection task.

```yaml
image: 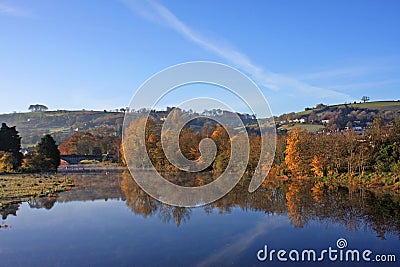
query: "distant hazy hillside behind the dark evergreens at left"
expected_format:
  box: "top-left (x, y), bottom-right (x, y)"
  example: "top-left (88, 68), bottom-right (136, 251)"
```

top-left (0, 110), bottom-right (124, 148)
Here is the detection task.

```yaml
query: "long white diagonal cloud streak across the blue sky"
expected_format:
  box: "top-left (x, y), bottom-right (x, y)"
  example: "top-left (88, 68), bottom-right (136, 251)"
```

top-left (123, 0), bottom-right (350, 101)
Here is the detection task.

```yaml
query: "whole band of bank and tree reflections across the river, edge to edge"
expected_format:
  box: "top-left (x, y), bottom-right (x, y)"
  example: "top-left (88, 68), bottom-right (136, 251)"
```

top-left (0, 172), bottom-right (400, 239)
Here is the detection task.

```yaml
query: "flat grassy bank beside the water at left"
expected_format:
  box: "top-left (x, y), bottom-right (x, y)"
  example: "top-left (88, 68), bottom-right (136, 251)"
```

top-left (0, 174), bottom-right (74, 209)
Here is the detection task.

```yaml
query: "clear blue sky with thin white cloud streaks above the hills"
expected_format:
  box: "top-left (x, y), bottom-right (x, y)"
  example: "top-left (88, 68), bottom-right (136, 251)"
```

top-left (0, 0), bottom-right (400, 115)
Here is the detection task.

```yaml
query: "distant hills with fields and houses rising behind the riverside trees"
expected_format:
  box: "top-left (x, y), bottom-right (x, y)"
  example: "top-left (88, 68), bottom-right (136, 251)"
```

top-left (0, 101), bottom-right (400, 148)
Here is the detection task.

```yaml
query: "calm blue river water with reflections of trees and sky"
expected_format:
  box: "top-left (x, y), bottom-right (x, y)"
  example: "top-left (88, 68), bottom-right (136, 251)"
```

top-left (0, 173), bottom-right (400, 266)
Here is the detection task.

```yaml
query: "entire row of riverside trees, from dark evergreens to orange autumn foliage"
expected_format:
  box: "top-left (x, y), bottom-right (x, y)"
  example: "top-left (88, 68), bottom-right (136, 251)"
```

top-left (0, 107), bottom-right (400, 184)
